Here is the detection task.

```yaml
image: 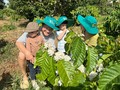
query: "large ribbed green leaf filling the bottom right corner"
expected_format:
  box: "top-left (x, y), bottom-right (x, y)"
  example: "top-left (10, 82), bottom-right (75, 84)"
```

top-left (98, 63), bottom-right (120, 90)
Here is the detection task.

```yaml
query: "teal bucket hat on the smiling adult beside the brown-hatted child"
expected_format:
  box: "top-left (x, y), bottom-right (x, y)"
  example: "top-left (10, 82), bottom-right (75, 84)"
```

top-left (42, 16), bottom-right (59, 30)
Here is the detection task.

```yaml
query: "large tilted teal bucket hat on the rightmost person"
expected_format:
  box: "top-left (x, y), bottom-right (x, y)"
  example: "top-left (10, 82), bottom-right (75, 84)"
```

top-left (77, 15), bottom-right (98, 34)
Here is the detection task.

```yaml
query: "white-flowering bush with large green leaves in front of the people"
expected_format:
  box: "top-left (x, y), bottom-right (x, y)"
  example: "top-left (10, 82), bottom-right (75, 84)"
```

top-left (35, 31), bottom-right (120, 90)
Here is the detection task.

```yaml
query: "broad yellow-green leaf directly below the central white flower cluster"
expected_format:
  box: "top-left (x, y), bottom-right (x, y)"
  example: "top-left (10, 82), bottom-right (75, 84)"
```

top-left (57, 60), bottom-right (75, 87)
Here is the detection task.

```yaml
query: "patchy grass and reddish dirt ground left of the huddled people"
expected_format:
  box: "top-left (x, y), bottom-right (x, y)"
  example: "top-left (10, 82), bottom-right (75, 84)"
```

top-left (0, 20), bottom-right (22, 90)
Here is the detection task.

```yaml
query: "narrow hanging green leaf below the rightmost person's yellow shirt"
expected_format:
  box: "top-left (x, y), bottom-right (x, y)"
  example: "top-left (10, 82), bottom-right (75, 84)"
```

top-left (86, 47), bottom-right (98, 72)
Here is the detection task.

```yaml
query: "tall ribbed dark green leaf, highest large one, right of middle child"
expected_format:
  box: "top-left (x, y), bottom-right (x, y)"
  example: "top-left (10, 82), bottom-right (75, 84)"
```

top-left (71, 37), bottom-right (86, 67)
